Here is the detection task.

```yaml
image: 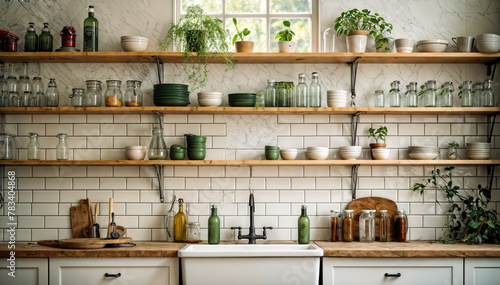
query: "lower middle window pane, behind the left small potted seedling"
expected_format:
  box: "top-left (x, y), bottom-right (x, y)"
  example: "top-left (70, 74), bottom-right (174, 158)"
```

top-left (226, 18), bottom-right (266, 52)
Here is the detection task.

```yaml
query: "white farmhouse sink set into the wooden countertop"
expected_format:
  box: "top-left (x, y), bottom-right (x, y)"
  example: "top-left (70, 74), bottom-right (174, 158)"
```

top-left (178, 244), bottom-right (323, 285)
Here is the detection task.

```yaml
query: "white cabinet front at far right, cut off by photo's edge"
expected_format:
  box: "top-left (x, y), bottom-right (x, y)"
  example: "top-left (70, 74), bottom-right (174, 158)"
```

top-left (465, 258), bottom-right (500, 285)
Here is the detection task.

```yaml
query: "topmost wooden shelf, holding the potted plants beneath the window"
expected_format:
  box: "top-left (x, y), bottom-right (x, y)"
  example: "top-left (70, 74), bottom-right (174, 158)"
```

top-left (0, 52), bottom-right (500, 64)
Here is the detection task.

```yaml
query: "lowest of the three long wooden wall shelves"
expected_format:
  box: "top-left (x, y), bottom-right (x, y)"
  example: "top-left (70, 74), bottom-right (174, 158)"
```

top-left (0, 160), bottom-right (500, 166)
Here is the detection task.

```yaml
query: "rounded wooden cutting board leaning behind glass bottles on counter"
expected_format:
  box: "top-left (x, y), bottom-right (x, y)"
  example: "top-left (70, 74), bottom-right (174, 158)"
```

top-left (347, 197), bottom-right (398, 241)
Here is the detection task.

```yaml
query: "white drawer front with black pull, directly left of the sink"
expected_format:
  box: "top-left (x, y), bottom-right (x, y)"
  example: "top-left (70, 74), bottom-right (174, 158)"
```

top-left (49, 257), bottom-right (179, 285)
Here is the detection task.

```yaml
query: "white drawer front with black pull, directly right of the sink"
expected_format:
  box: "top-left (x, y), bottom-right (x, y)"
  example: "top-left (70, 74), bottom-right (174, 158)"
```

top-left (323, 257), bottom-right (463, 285)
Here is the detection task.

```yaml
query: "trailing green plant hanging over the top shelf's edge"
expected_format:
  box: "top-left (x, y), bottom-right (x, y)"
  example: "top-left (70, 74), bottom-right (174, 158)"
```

top-left (159, 5), bottom-right (234, 90)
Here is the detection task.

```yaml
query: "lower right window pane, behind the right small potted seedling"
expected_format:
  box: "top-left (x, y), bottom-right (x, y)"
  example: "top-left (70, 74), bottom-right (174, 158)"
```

top-left (270, 18), bottom-right (311, 52)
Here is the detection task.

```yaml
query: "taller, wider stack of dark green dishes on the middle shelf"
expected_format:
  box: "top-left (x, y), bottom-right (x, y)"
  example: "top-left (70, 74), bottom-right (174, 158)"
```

top-left (153, 83), bottom-right (189, 106)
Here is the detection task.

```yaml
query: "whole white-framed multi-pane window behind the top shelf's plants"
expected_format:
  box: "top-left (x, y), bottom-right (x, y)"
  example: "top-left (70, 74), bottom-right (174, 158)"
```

top-left (174, 0), bottom-right (319, 52)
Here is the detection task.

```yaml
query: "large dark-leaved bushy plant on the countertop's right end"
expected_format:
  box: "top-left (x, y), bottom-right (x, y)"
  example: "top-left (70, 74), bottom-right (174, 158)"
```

top-left (413, 166), bottom-right (500, 244)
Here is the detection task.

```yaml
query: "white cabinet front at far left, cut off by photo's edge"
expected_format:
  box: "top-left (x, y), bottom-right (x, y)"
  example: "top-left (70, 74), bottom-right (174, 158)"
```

top-left (0, 258), bottom-right (49, 285)
